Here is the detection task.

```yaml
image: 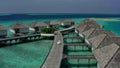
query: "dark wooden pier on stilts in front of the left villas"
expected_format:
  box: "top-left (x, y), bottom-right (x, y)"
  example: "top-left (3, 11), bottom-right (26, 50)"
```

top-left (0, 34), bottom-right (41, 47)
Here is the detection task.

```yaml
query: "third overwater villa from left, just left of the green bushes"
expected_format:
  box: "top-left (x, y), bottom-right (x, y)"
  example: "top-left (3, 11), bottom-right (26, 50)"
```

top-left (29, 22), bottom-right (49, 32)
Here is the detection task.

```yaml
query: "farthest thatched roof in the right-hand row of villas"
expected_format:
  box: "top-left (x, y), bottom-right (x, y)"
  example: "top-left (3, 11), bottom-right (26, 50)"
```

top-left (75, 19), bottom-right (102, 31)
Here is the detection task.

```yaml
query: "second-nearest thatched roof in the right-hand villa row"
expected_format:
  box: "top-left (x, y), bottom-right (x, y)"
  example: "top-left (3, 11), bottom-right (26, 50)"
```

top-left (89, 30), bottom-right (115, 49)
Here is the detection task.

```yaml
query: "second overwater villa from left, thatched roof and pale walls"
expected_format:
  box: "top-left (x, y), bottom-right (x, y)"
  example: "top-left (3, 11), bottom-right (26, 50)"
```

top-left (10, 22), bottom-right (29, 34)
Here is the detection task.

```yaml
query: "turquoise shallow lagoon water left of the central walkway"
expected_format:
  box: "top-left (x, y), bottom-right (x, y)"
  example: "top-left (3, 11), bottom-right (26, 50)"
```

top-left (0, 40), bottom-right (53, 68)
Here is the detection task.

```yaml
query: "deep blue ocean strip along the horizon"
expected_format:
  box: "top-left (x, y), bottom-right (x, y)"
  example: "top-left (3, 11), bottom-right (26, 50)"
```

top-left (0, 13), bottom-right (120, 20)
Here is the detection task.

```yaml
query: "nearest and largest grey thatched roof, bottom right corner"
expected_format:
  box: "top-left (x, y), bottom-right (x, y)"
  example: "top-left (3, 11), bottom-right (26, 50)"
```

top-left (93, 43), bottom-right (120, 68)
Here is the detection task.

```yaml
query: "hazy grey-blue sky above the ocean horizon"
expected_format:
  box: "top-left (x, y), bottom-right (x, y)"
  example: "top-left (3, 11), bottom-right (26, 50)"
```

top-left (0, 0), bottom-right (120, 14)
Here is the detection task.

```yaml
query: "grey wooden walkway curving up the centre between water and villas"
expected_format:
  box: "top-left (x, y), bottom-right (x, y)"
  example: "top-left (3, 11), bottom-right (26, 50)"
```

top-left (42, 32), bottom-right (64, 68)
